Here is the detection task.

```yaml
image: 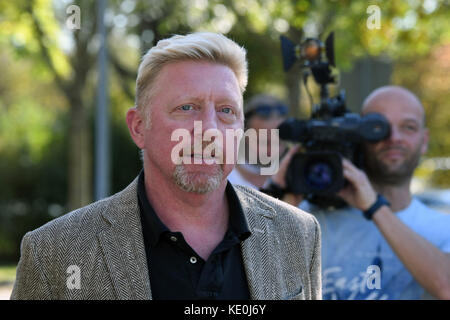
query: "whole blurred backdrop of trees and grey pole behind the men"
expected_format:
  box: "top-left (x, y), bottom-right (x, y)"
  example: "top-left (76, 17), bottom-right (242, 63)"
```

top-left (0, 0), bottom-right (450, 296)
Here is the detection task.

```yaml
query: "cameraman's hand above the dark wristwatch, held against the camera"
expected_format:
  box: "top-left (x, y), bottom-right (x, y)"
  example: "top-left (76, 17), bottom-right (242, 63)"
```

top-left (337, 159), bottom-right (377, 211)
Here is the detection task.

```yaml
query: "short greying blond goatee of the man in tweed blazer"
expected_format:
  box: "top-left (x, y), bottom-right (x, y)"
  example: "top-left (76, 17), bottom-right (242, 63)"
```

top-left (172, 164), bottom-right (223, 194)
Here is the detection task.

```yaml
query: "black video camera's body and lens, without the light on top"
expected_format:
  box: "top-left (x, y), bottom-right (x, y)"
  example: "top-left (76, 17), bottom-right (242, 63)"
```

top-left (279, 113), bottom-right (389, 206)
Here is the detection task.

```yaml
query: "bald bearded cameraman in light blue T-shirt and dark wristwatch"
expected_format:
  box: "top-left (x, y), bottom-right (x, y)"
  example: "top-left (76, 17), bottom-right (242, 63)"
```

top-left (272, 86), bottom-right (450, 299)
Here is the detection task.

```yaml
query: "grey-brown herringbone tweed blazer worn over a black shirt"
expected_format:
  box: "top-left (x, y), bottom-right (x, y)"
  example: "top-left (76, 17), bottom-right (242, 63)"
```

top-left (11, 179), bottom-right (321, 300)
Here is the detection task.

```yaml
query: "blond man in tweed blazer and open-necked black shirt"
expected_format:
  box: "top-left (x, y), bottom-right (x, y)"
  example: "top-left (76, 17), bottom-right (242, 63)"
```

top-left (12, 33), bottom-right (321, 300)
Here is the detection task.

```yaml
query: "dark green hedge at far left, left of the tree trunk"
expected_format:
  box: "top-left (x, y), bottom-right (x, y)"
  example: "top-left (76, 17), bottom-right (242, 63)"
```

top-left (0, 119), bottom-right (67, 261)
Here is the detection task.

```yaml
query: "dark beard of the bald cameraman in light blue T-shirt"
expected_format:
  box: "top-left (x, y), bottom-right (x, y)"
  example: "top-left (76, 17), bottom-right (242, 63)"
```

top-left (365, 147), bottom-right (421, 186)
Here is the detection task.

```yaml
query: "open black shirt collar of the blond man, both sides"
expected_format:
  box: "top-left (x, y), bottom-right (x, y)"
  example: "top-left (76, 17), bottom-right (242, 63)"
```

top-left (137, 170), bottom-right (251, 246)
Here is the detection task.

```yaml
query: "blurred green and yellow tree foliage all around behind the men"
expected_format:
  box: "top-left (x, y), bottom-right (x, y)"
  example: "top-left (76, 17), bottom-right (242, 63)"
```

top-left (0, 0), bottom-right (450, 260)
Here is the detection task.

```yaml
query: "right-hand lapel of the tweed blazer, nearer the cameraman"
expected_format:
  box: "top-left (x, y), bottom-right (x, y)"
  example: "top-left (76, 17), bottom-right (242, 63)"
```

top-left (235, 188), bottom-right (284, 300)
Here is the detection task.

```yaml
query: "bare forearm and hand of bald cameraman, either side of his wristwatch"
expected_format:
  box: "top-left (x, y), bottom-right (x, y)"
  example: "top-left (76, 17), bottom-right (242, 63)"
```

top-left (338, 160), bottom-right (450, 299)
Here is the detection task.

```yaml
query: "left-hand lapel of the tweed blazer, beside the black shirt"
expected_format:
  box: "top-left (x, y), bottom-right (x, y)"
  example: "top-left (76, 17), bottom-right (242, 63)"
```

top-left (97, 179), bottom-right (151, 300)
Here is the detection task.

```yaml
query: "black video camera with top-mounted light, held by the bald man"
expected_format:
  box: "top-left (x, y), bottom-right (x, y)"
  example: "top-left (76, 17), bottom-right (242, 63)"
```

top-left (279, 33), bottom-right (390, 207)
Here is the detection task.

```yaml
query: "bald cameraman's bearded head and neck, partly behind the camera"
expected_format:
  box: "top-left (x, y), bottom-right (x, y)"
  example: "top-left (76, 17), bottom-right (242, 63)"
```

top-left (361, 86), bottom-right (428, 211)
